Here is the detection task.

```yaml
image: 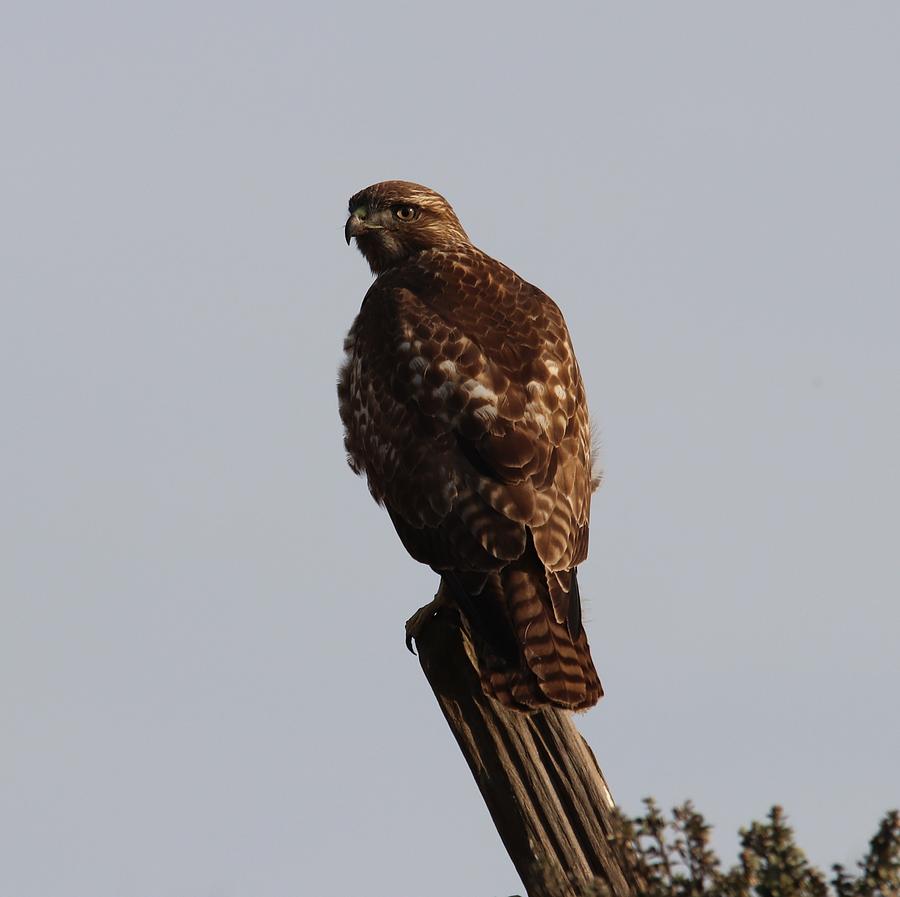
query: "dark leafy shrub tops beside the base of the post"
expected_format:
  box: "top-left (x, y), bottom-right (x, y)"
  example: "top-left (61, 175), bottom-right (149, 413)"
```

top-left (599, 799), bottom-right (900, 897)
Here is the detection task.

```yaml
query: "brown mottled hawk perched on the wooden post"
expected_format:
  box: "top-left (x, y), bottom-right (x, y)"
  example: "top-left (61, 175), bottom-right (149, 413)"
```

top-left (338, 181), bottom-right (603, 711)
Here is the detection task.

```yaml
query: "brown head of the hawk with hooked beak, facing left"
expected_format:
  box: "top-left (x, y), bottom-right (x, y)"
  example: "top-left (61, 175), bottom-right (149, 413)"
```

top-left (344, 181), bottom-right (469, 274)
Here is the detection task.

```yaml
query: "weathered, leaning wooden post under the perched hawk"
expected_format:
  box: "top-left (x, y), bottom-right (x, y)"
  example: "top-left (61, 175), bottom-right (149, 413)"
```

top-left (416, 608), bottom-right (636, 897)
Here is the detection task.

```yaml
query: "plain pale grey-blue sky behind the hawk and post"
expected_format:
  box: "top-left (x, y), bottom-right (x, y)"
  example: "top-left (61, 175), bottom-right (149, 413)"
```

top-left (0, 0), bottom-right (900, 897)
